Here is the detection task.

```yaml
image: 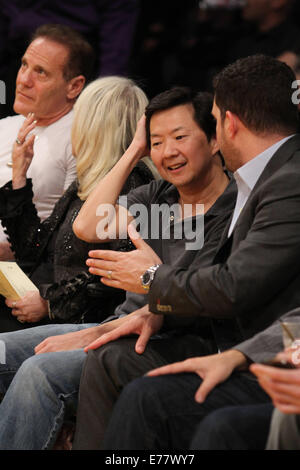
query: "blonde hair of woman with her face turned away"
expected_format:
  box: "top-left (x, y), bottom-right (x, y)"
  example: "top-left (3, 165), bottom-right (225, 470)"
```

top-left (72, 76), bottom-right (157, 201)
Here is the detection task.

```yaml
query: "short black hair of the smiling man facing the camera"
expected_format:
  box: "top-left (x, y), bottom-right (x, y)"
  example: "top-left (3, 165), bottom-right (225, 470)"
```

top-left (145, 87), bottom-right (216, 148)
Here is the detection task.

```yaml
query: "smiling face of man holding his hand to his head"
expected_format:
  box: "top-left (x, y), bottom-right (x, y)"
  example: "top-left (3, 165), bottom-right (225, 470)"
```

top-left (150, 104), bottom-right (218, 191)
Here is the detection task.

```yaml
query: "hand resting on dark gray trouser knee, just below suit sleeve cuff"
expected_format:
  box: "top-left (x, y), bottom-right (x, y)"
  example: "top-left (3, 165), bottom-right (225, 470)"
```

top-left (85, 305), bottom-right (164, 354)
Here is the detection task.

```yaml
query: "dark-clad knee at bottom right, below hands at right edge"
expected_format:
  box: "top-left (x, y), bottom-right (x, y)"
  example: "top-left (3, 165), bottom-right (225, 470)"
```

top-left (191, 403), bottom-right (274, 450)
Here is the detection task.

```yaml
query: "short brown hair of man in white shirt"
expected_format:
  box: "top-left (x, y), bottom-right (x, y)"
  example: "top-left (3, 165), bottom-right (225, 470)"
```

top-left (30, 24), bottom-right (95, 82)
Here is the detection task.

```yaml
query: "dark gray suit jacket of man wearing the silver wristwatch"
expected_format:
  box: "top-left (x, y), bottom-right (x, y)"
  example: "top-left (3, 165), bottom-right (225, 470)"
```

top-left (149, 135), bottom-right (300, 349)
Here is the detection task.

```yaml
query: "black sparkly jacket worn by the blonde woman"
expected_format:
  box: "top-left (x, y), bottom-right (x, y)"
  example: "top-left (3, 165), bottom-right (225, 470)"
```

top-left (0, 162), bottom-right (153, 322)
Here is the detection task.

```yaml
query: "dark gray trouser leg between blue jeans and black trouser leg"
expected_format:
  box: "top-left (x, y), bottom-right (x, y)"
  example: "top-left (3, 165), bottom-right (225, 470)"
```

top-left (73, 334), bottom-right (216, 450)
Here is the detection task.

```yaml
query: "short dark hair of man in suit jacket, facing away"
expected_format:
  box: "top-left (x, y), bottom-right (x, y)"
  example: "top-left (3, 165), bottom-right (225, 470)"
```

top-left (213, 54), bottom-right (299, 134)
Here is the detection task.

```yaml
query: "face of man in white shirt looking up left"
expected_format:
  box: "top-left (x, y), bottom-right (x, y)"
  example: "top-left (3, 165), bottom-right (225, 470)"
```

top-left (14, 37), bottom-right (73, 122)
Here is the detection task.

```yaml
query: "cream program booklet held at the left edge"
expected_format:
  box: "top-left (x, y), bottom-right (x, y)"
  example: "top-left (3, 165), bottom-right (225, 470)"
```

top-left (0, 261), bottom-right (38, 300)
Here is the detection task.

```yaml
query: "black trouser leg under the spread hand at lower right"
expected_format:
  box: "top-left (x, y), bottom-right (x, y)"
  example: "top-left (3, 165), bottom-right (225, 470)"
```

top-left (102, 373), bottom-right (270, 450)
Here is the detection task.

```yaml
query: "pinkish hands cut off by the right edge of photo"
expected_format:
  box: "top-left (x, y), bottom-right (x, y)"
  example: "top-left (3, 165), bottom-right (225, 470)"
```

top-left (250, 346), bottom-right (300, 414)
